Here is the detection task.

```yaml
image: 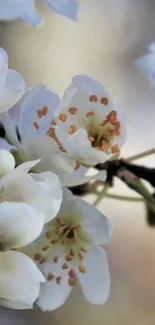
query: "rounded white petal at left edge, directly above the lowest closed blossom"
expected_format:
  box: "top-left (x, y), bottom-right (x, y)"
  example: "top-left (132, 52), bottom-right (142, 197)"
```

top-left (0, 202), bottom-right (44, 249)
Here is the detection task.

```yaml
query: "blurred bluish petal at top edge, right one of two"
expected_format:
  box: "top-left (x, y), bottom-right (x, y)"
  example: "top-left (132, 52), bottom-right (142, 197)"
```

top-left (47, 0), bottom-right (78, 20)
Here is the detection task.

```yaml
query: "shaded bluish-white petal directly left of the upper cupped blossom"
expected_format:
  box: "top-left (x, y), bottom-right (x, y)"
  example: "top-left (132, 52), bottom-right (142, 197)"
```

top-left (18, 86), bottom-right (59, 141)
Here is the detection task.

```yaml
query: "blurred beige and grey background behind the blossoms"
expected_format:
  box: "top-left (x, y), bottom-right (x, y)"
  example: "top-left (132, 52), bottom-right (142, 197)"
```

top-left (0, 0), bottom-right (155, 325)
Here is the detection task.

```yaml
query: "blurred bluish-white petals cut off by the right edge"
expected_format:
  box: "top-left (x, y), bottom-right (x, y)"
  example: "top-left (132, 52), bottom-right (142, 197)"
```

top-left (135, 43), bottom-right (155, 88)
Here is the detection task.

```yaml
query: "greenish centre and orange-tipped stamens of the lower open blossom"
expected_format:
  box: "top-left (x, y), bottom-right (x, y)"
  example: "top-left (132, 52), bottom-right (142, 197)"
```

top-left (34, 217), bottom-right (90, 286)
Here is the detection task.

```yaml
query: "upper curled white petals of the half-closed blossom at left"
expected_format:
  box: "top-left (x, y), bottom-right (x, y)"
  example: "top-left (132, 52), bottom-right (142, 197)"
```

top-left (0, 161), bottom-right (62, 224)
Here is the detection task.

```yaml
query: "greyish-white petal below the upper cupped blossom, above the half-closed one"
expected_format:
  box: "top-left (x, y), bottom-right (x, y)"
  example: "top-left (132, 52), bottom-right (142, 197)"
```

top-left (23, 136), bottom-right (75, 176)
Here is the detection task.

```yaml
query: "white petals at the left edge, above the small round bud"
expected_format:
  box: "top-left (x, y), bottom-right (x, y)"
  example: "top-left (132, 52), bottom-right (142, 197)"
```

top-left (0, 48), bottom-right (26, 114)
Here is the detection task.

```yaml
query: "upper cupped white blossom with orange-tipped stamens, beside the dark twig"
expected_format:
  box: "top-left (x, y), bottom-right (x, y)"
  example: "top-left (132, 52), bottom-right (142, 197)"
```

top-left (55, 75), bottom-right (125, 166)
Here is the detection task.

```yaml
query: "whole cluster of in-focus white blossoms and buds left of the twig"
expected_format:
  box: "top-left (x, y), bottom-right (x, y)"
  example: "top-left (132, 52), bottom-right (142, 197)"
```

top-left (0, 49), bottom-right (125, 310)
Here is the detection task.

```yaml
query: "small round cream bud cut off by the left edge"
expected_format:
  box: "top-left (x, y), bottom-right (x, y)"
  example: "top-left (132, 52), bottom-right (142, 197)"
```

top-left (0, 149), bottom-right (15, 177)
